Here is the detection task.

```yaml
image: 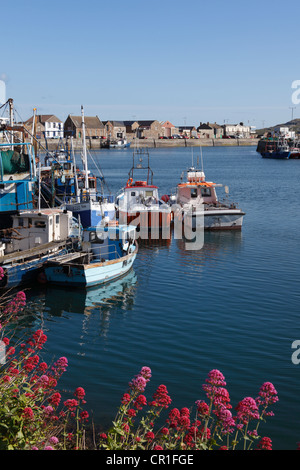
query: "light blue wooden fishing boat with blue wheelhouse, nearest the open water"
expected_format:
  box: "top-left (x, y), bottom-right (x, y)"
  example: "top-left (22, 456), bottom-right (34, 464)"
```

top-left (44, 225), bottom-right (138, 288)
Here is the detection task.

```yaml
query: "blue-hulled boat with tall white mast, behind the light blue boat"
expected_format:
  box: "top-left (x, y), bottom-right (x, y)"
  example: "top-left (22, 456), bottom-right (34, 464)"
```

top-left (63, 106), bottom-right (116, 228)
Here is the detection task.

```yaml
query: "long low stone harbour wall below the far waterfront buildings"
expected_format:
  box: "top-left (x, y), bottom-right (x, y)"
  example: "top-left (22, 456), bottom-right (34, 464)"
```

top-left (40, 138), bottom-right (259, 151)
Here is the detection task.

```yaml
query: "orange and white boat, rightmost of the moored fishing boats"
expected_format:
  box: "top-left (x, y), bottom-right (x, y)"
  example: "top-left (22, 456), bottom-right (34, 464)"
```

top-left (171, 167), bottom-right (245, 230)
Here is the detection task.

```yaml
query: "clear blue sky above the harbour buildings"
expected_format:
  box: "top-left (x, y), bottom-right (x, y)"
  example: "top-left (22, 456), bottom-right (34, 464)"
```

top-left (0, 0), bottom-right (300, 128)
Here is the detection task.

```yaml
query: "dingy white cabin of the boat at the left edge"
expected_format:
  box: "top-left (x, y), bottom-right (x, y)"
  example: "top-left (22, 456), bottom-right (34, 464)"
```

top-left (5, 209), bottom-right (74, 253)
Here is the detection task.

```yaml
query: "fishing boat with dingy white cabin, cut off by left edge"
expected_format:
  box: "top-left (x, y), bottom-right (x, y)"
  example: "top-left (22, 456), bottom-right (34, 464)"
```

top-left (0, 208), bottom-right (80, 289)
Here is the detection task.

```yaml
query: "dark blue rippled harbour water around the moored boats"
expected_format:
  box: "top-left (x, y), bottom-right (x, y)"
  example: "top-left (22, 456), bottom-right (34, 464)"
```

top-left (16, 147), bottom-right (300, 449)
